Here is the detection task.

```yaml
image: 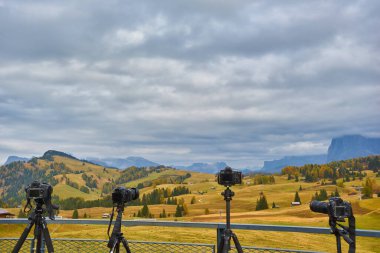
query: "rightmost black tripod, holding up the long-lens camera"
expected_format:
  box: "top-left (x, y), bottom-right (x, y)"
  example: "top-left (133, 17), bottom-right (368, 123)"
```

top-left (329, 214), bottom-right (356, 253)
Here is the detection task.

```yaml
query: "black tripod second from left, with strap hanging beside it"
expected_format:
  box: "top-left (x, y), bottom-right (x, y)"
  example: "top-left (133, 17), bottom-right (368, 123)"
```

top-left (107, 204), bottom-right (131, 253)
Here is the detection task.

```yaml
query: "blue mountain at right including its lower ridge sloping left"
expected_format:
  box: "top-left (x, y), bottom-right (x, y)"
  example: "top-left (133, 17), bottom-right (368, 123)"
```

top-left (261, 135), bottom-right (380, 173)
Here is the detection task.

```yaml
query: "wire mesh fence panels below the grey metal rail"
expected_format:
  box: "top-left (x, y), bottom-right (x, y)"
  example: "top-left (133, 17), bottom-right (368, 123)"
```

top-left (0, 238), bottom-right (324, 253)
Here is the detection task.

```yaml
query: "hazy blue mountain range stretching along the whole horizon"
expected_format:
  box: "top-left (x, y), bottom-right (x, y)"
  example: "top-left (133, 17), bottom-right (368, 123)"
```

top-left (5, 135), bottom-right (380, 173)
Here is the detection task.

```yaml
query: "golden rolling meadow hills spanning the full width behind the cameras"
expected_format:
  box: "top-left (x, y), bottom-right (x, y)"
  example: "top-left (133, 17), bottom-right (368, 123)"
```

top-left (0, 151), bottom-right (380, 252)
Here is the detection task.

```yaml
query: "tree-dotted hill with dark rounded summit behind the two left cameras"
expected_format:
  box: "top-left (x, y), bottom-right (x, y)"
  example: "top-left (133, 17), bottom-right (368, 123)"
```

top-left (0, 150), bottom-right (200, 206)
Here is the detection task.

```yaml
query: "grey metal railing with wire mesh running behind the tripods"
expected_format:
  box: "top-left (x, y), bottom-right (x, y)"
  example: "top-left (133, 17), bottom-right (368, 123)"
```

top-left (0, 219), bottom-right (380, 253)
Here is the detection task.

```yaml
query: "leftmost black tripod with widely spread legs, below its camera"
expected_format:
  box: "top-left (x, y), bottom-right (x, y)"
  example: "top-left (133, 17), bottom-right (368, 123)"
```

top-left (12, 202), bottom-right (54, 253)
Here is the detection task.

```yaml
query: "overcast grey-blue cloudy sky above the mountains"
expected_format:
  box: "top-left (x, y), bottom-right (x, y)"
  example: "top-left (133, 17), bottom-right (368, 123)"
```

top-left (0, 0), bottom-right (380, 167)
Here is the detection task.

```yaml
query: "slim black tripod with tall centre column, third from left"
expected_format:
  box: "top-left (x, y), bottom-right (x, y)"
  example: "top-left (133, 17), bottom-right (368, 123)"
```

top-left (218, 186), bottom-right (243, 253)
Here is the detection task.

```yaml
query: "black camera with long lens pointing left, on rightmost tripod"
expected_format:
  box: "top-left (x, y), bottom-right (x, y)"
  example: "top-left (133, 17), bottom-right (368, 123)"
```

top-left (310, 197), bottom-right (353, 220)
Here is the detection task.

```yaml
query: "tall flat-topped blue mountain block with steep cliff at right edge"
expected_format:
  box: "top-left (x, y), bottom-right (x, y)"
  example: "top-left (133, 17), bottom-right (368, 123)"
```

top-left (327, 135), bottom-right (380, 162)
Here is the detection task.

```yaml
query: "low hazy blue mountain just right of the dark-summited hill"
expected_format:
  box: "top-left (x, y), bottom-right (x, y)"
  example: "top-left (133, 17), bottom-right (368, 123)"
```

top-left (86, 156), bottom-right (160, 169)
